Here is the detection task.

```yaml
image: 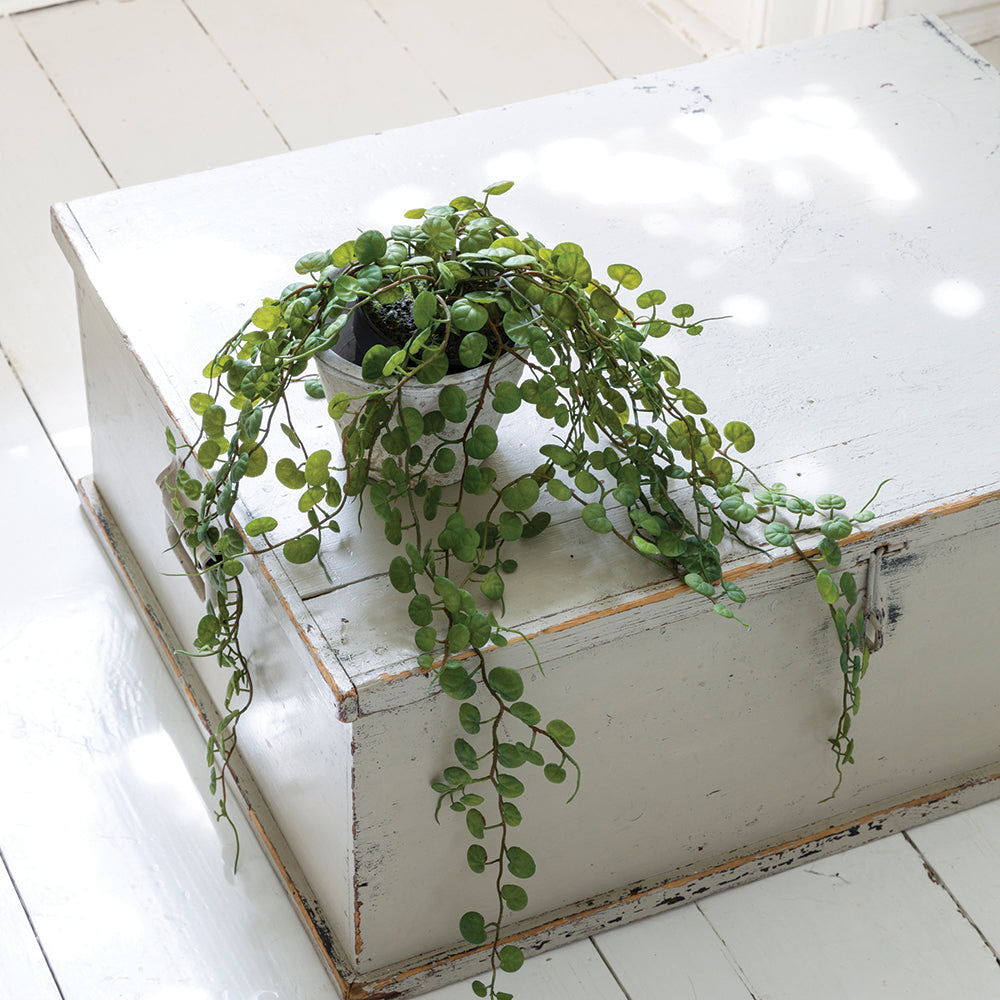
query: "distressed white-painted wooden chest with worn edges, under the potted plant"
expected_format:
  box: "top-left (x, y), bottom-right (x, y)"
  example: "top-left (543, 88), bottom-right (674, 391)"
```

top-left (54, 18), bottom-right (1000, 997)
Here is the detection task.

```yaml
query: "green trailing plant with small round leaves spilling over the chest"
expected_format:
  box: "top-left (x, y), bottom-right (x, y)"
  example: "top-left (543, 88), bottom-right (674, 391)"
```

top-left (168, 182), bottom-right (877, 1000)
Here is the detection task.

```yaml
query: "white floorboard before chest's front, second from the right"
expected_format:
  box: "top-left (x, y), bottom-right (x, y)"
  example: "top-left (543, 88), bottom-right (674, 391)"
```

top-left (696, 837), bottom-right (1000, 1000)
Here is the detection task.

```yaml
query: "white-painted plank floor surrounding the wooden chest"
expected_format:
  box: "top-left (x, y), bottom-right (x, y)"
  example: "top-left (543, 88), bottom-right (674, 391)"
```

top-left (0, 0), bottom-right (1000, 1000)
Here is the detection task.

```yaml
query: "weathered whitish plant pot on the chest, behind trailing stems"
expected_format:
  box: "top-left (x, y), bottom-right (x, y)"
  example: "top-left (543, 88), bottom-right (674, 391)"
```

top-left (316, 312), bottom-right (524, 486)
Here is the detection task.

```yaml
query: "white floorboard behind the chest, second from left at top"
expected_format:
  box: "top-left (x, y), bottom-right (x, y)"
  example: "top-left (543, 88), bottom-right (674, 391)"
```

top-left (17, 0), bottom-right (288, 184)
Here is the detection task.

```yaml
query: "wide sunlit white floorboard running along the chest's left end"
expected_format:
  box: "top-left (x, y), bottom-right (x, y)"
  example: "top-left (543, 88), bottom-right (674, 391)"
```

top-left (0, 354), bottom-right (337, 1000)
